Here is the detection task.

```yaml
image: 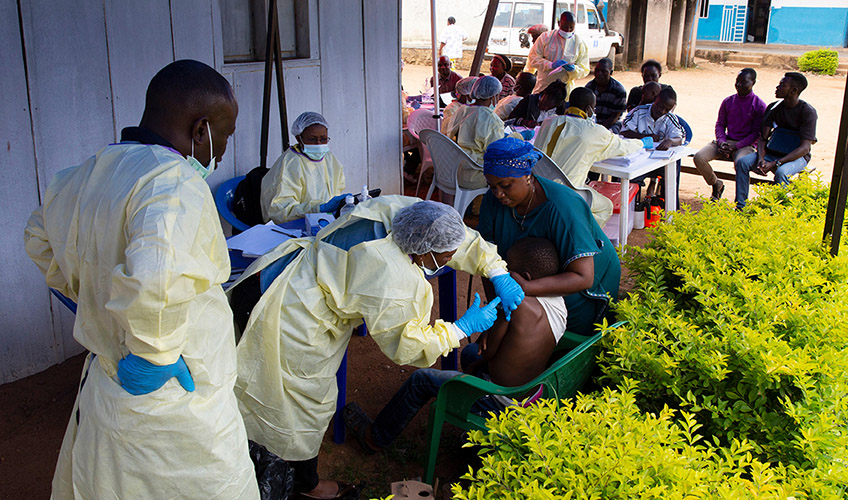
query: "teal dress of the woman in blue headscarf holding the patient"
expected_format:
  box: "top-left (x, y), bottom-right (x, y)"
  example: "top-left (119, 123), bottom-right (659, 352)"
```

top-left (477, 177), bottom-right (621, 335)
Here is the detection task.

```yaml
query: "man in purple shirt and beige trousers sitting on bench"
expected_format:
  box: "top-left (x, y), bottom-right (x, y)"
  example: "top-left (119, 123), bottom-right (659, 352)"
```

top-left (694, 68), bottom-right (766, 201)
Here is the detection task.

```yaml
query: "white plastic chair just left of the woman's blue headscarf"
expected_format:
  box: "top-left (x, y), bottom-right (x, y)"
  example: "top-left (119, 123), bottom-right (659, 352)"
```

top-left (421, 130), bottom-right (489, 215)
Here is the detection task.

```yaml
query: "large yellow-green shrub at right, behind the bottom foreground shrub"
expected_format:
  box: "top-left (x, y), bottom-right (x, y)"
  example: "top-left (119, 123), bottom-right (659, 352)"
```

top-left (599, 179), bottom-right (848, 493)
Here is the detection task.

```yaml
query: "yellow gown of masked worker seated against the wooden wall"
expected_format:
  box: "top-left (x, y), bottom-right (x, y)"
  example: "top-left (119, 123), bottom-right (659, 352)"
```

top-left (261, 146), bottom-right (345, 224)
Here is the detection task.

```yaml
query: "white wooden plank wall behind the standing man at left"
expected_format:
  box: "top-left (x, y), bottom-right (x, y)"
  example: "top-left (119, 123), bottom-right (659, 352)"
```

top-left (0, 0), bottom-right (401, 383)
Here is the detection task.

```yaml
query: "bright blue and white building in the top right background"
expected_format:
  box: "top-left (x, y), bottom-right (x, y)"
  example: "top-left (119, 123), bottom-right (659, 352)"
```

top-left (697, 0), bottom-right (848, 47)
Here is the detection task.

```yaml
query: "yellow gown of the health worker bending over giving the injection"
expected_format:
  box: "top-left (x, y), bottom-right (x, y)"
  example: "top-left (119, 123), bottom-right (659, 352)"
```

top-left (236, 196), bottom-right (506, 460)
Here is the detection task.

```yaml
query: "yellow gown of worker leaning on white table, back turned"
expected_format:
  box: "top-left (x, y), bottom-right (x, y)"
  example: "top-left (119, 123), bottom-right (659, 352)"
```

top-left (535, 113), bottom-right (642, 227)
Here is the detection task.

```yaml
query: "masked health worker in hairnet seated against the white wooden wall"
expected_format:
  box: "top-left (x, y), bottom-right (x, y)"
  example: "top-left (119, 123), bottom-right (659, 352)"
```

top-left (261, 111), bottom-right (350, 224)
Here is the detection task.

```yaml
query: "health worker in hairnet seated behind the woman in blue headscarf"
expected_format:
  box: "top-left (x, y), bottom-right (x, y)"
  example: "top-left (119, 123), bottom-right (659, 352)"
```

top-left (444, 75), bottom-right (504, 189)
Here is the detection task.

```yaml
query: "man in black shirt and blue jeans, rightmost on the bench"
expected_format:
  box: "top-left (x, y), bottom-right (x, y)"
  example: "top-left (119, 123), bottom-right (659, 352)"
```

top-left (736, 72), bottom-right (818, 210)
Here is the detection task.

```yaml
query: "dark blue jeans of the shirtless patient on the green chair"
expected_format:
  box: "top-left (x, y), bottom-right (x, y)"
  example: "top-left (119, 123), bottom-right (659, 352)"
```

top-left (371, 344), bottom-right (503, 448)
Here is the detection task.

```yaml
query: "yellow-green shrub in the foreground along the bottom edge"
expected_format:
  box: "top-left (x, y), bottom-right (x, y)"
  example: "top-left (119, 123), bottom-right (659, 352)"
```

top-left (453, 381), bottom-right (803, 500)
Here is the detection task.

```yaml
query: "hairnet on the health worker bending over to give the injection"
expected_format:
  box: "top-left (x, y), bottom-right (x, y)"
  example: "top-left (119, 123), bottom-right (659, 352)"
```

top-left (392, 201), bottom-right (465, 255)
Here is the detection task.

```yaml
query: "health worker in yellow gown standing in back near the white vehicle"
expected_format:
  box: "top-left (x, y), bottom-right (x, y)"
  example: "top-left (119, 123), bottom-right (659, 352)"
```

top-left (527, 11), bottom-right (589, 100)
